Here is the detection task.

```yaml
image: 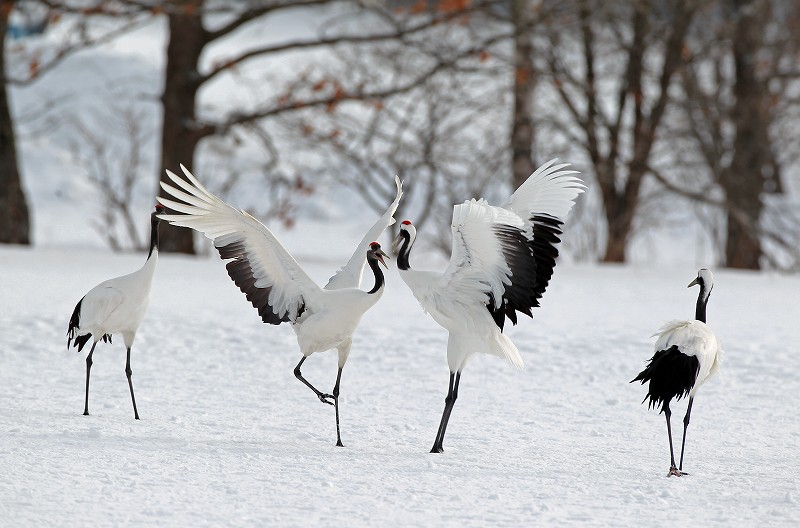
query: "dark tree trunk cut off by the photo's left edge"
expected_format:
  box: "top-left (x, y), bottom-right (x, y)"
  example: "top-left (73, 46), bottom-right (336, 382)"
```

top-left (0, 0), bottom-right (31, 244)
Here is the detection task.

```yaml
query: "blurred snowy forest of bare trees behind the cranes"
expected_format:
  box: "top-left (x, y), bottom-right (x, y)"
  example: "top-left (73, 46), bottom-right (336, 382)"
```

top-left (0, 0), bottom-right (800, 271)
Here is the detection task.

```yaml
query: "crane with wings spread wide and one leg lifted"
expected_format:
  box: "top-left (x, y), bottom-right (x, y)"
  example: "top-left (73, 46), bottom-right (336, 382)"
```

top-left (159, 165), bottom-right (403, 447)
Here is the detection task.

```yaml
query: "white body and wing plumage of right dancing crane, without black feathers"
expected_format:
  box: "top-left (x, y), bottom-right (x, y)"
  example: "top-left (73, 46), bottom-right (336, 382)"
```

top-left (399, 160), bottom-right (584, 372)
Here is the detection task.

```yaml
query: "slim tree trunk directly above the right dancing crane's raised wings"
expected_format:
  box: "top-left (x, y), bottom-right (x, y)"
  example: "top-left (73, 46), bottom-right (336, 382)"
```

top-left (511, 0), bottom-right (536, 189)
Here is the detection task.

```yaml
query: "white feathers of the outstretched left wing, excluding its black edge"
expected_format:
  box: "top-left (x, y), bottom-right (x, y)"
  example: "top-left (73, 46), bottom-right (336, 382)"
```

top-left (158, 165), bottom-right (320, 316)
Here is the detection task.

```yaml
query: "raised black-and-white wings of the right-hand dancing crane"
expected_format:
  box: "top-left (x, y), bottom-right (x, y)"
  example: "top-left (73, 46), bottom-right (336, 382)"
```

top-left (434, 160), bottom-right (584, 329)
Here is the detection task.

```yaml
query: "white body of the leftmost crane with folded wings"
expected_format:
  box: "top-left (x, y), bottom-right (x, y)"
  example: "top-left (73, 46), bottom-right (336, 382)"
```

top-left (70, 255), bottom-right (158, 348)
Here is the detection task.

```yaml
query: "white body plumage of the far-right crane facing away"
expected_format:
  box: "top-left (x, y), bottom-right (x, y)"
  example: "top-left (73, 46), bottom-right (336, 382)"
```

top-left (653, 320), bottom-right (722, 398)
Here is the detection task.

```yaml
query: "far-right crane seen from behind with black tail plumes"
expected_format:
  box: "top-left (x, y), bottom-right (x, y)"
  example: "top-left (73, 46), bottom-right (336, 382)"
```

top-left (631, 269), bottom-right (722, 477)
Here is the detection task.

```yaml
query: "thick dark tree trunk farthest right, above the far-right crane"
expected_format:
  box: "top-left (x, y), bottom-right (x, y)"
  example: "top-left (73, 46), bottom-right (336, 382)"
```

top-left (720, 0), bottom-right (772, 269)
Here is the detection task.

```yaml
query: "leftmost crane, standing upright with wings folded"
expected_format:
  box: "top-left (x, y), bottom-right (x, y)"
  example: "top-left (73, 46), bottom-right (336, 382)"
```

top-left (67, 205), bottom-right (164, 420)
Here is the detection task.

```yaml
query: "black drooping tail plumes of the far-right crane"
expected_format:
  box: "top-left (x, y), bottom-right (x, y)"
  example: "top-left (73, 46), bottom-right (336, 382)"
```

top-left (631, 345), bottom-right (700, 412)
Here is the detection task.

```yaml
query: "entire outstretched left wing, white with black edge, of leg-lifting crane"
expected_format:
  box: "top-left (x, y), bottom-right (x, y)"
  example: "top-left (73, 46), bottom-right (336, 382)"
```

top-left (158, 165), bottom-right (318, 324)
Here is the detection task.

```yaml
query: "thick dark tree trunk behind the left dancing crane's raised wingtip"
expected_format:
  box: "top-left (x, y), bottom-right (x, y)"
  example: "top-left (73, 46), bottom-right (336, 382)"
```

top-left (159, 0), bottom-right (207, 253)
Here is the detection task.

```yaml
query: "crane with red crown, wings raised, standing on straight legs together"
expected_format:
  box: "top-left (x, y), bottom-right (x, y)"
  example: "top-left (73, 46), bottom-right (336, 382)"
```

top-left (393, 160), bottom-right (585, 453)
